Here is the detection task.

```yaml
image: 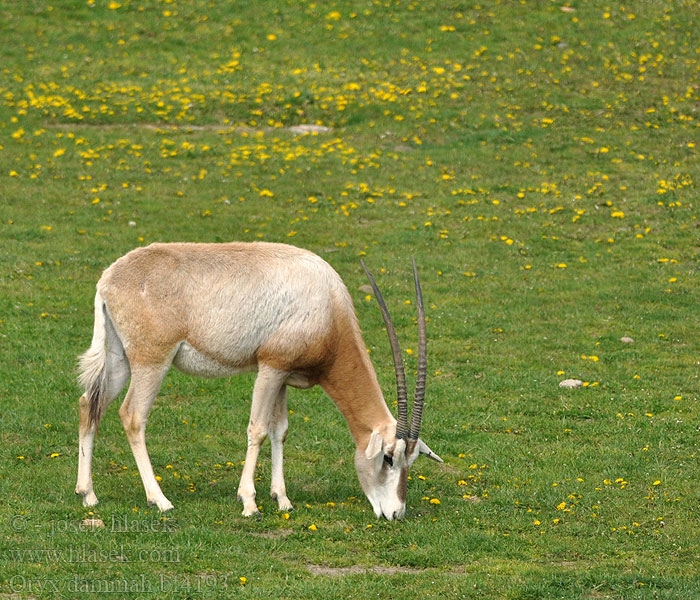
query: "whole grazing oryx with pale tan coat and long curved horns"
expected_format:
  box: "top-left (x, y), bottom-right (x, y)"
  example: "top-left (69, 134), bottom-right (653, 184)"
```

top-left (75, 242), bottom-right (442, 520)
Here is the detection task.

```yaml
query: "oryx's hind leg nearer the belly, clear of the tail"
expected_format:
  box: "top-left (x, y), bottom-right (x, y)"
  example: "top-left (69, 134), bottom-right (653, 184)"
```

top-left (119, 366), bottom-right (173, 511)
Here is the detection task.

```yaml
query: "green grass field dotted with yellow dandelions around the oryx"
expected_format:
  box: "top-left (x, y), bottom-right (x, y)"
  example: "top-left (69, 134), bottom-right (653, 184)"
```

top-left (0, 0), bottom-right (700, 600)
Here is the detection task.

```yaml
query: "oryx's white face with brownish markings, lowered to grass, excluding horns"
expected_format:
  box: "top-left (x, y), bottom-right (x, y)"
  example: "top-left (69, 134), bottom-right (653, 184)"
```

top-left (355, 431), bottom-right (419, 521)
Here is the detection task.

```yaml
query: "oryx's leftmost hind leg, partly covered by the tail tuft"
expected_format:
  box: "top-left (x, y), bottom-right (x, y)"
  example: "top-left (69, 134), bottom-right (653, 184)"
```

top-left (75, 353), bottom-right (129, 506)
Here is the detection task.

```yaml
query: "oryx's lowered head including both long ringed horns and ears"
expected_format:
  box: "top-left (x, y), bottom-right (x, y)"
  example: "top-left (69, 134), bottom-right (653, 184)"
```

top-left (355, 260), bottom-right (442, 521)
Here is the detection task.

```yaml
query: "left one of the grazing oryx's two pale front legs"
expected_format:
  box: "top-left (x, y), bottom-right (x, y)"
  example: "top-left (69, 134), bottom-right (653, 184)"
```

top-left (238, 365), bottom-right (287, 517)
